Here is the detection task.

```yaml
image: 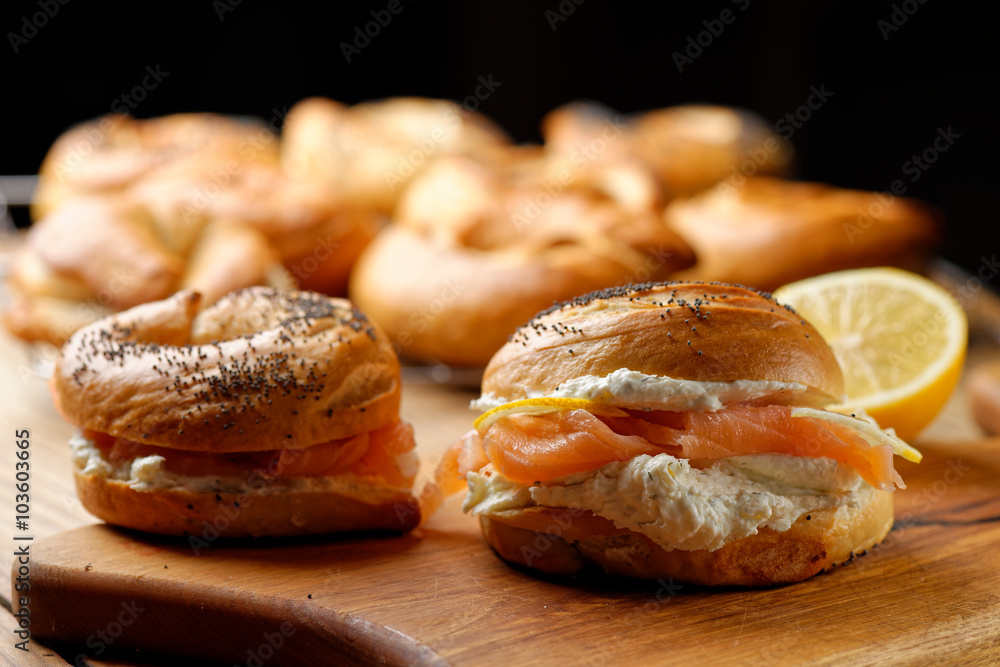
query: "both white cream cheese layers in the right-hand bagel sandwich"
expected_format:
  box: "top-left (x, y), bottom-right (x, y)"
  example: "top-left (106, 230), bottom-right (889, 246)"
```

top-left (463, 368), bottom-right (920, 551)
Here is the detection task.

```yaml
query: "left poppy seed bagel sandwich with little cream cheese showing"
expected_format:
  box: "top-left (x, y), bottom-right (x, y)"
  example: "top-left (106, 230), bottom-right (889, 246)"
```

top-left (51, 287), bottom-right (420, 539)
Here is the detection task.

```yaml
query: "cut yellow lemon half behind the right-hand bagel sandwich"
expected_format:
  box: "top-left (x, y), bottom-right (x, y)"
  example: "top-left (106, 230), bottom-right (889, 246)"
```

top-left (774, 268), bottom-right (968, 440)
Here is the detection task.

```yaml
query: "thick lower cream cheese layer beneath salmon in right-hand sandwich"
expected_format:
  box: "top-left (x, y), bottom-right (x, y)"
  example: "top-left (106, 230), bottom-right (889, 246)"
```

top-left (463, 454), bottom-right (886, 551)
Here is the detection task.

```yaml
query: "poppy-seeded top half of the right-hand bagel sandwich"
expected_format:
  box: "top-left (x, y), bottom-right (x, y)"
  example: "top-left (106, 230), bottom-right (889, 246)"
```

top-left (482, 282), bottom-right (844, 402)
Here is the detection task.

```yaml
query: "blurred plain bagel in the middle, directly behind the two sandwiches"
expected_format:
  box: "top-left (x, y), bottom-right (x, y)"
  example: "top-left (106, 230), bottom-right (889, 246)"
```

top-left (351, 149), bottom-right (694, 366)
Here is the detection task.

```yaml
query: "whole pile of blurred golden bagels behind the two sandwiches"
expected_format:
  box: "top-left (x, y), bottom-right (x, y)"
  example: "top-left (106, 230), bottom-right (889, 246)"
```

top-left (4, 98), bottom-right (940, 367)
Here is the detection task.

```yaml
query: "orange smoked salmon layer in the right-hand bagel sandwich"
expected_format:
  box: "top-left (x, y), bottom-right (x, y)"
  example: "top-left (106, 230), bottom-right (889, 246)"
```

top-left (466, 405), bottom-right (903, 490)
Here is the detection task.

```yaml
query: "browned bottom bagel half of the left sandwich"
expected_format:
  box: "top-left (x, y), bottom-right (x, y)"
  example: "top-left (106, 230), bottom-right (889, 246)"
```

top-left (74, 471), bottom-right (420, 536)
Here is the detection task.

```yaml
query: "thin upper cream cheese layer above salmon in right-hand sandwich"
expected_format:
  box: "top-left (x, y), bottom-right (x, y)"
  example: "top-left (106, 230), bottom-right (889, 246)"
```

top-left (470, 368), bottom-right (810, 412)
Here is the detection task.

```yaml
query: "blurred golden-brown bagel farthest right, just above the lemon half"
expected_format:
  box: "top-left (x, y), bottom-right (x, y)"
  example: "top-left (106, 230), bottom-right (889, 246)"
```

top-left (664, 177), bottom-right (941, 290)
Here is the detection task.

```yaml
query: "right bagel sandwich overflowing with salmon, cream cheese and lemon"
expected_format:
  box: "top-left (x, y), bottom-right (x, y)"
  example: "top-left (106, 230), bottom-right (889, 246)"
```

top-left (446, 282), bottom-right (920, 586)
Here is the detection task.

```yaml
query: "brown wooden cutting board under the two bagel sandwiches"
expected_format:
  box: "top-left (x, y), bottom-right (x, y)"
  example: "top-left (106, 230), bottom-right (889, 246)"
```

top-left (19, 439), bottom-right (1000, 665)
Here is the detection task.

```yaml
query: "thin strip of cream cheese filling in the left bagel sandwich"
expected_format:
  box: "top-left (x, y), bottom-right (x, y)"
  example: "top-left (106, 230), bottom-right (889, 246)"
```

top-left (69, 432), bottom-right (416, 503)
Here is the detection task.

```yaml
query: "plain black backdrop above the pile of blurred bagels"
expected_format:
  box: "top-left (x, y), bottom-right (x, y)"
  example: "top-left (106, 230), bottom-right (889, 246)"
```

top-left (0, 0), bottom-right (1000, 271)
